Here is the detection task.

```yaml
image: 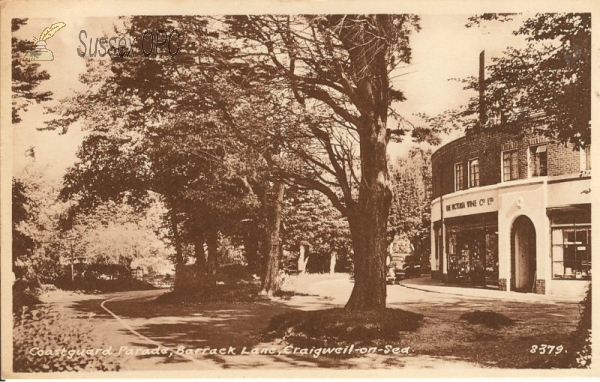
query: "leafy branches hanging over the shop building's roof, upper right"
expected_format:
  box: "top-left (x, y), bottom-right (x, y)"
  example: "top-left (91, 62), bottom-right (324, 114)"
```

top-left (429, 13), bottom-right (591, 147)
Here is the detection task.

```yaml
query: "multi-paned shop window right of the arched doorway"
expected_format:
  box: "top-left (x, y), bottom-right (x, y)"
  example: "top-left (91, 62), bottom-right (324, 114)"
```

top-left (552, 227), bottom-right (592, 280)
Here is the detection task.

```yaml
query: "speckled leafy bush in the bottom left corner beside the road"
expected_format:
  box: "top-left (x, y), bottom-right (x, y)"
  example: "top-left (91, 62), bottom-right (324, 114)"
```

top-left (13, 307), bottom-right (120, 372)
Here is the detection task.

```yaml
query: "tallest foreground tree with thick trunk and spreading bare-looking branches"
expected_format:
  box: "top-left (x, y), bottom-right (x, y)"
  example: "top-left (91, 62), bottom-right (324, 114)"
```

top-left (228, 15), bottom-right (418, 310)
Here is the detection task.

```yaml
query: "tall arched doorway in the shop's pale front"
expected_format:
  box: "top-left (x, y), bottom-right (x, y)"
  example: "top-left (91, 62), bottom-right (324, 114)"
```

top-left (512, 216), bottom-right (536, 292)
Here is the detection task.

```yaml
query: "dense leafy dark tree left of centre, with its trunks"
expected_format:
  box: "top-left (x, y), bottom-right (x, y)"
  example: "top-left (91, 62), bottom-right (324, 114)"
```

top-left (46, 17), bottom-right (264, 290)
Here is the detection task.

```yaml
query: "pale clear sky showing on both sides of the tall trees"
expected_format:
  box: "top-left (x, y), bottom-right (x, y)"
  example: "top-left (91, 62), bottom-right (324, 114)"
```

top-left (13, 13), bottom-right (523, 178)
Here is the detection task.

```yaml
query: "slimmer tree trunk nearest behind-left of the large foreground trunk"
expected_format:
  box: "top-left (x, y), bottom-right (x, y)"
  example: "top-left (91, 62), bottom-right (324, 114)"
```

top-left (260, 181), bottom-right (285, 295)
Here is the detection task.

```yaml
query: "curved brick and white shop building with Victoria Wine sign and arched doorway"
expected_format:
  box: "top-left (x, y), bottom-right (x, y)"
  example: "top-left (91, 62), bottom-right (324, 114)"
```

top-left (430, 131), bottom-right (592, 296)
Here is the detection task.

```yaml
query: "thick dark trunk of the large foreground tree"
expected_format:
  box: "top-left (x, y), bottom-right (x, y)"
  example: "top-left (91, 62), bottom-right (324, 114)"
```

top-left (340, 15), bottom-right (394, 310)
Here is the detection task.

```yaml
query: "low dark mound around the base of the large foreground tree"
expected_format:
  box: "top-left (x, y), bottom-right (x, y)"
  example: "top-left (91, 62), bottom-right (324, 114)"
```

top-left (267, 308), bottom-right (423, 347)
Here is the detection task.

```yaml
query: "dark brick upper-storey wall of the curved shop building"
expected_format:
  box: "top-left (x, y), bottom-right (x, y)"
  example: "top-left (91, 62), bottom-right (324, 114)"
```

top-left (431, 131), bottom-right (580, 198)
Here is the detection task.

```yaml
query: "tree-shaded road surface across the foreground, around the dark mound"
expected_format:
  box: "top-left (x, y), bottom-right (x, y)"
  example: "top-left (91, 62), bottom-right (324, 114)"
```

top-left (36, 275), bottom-right (579, 370)
